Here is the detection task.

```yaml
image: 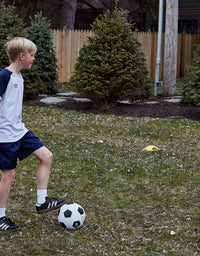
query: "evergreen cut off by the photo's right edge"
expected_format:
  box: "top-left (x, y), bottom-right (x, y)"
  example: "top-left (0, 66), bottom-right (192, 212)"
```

top-left (182, 45), bottom-right (200, 105)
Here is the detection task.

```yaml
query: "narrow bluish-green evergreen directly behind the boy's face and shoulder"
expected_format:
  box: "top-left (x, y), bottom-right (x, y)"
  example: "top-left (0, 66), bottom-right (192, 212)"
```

top-left (24, 13), bottom-right (58, 98)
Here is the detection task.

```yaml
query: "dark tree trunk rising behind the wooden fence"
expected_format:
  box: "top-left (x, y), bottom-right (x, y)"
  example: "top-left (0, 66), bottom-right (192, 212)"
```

top-left (61, 0), bottom-right (77, 30)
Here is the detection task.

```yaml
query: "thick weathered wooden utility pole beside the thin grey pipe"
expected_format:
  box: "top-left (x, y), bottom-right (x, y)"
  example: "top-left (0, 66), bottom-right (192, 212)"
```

top-left (163, 0), bottom-right (178, 96)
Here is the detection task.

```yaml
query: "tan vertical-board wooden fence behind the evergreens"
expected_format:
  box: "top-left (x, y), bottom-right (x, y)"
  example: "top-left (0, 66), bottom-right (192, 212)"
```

top-left (52, 30), bottom-right (200, 82)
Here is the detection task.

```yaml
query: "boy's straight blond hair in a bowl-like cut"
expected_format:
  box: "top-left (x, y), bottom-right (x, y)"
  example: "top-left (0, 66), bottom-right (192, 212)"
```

top-left (5, 37), bottom-right (37, 62)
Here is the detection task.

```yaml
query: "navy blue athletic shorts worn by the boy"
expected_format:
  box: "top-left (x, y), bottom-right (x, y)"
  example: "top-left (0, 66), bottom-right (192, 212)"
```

top-left (0, 131), bottom-right (43, 170)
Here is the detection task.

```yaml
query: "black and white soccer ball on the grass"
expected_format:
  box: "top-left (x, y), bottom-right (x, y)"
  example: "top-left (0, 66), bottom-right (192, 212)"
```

top-left (58, 203), bottom-right (85, 229)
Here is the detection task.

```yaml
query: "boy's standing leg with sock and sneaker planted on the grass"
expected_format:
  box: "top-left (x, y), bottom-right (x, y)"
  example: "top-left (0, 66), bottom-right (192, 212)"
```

top-left (0, 169), bottom-right (21, 231)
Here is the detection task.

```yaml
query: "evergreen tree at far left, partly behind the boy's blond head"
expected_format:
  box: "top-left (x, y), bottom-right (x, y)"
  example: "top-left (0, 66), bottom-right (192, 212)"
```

top-left (0, 2), bottom-right (24, 69)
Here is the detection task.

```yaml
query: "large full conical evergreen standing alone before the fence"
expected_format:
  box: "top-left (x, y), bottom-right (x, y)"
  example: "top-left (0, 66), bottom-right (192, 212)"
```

top-left (70, 10), bottom-right (151, 105)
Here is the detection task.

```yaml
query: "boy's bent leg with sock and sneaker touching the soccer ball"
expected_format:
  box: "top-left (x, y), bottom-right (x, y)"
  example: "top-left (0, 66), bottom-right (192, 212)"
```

top-left (33, 146), bottom-right (66, 213)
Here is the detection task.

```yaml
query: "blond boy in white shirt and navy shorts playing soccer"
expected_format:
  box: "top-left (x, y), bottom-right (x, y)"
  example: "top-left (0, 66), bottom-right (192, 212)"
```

top-left (0, 37), bottom-right (66, 231)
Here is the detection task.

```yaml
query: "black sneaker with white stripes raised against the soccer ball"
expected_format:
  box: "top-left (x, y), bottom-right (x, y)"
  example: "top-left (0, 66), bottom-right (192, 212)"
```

top-left (36, 196), bottom-right (66, 214)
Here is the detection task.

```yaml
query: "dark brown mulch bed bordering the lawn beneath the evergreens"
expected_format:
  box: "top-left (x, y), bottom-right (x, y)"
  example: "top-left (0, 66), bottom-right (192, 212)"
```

top-left (24, 96), bottom-right (200, 120)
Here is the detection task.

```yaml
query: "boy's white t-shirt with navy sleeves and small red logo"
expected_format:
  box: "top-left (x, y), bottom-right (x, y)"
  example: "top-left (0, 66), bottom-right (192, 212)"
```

top-left (0, 69), bottom-right (28, 143)
